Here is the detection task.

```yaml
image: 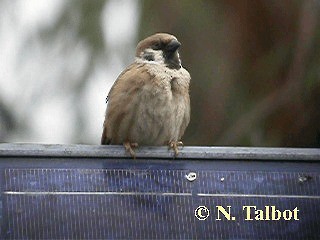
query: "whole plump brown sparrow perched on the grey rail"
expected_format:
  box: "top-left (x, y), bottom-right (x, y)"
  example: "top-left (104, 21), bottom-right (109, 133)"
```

top-left (101, 33), bottom-right (191, 157)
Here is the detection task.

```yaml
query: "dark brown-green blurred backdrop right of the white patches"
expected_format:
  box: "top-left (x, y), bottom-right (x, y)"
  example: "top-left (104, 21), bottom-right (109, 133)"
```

top-left (140, 0), bottom-right (320, 147)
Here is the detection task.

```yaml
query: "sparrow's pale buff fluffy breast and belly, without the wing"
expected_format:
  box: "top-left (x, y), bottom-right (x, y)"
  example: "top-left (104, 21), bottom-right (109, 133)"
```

top-left (127, 65), bottom-right (190, 145)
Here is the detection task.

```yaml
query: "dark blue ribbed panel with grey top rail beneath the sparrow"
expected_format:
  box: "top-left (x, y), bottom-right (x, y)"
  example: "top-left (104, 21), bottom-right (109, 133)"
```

top-left (0, 143), bottom-right (320, 239)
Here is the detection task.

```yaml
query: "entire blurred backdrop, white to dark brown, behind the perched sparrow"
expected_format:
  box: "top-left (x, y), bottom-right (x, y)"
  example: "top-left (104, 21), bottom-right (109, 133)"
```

top-left (0, 0), bottom-right (320, 147)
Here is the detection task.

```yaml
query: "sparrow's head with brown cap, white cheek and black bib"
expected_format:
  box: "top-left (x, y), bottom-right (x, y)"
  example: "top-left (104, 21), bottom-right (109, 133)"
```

top-left (136, 33), bottom-right (181, 69)
